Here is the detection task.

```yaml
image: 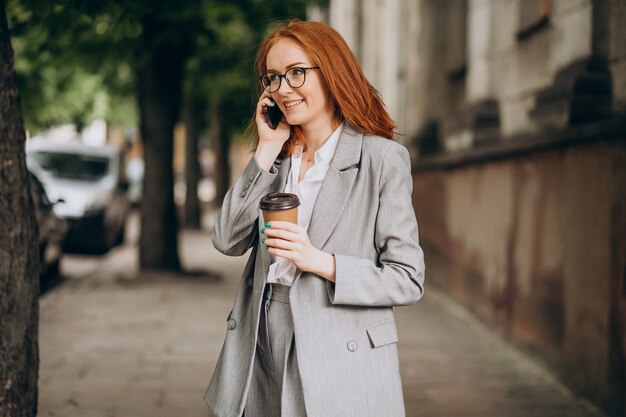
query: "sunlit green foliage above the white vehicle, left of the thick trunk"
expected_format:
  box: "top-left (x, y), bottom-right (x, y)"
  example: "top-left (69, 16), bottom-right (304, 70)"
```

top-left (7, 0), bottom-right (140, 131)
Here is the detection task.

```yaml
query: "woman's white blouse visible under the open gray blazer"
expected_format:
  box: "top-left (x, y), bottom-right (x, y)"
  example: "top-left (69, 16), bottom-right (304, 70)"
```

top-left (267, 123), bottom-right (343, 286)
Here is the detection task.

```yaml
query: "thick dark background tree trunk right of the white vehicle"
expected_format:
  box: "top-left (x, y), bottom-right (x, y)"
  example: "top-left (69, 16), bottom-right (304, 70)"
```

top-left (137, 13), bottom-right (184, 270)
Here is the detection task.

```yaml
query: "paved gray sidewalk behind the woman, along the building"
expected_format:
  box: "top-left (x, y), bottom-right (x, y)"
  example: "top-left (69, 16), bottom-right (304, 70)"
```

top-left (39, 218), bottom-right (601, 417)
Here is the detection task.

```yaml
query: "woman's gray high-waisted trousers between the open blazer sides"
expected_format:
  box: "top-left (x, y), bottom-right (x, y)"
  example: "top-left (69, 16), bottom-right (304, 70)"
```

top-left (244, 284), bottom-right (306, 417)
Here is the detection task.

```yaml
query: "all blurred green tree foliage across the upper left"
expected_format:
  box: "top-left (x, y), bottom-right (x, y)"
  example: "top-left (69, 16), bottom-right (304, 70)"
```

top-left (7, 0), bottom-right (306, 135)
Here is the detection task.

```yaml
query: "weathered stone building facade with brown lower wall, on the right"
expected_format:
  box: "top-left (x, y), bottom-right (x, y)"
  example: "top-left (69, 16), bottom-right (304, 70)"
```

top-left (317, 0), bottom-right (626, 415)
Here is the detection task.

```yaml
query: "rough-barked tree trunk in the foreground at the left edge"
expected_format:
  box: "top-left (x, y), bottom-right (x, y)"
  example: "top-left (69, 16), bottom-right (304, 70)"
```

top-left (0, 0), bottom-right (39, 417)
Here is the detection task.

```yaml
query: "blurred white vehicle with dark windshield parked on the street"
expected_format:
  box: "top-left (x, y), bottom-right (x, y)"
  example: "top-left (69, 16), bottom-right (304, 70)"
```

top-left (27, 139), bottom-right (130, 253)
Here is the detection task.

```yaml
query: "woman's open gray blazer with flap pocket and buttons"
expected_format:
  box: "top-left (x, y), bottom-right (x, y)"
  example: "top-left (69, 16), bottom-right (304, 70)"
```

top-left (204, 124), bottom-right (424, 417)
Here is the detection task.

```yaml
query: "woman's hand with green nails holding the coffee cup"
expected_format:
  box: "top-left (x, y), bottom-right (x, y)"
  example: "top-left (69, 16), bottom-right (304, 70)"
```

top-left (261, 221), bottom-right (335, 281)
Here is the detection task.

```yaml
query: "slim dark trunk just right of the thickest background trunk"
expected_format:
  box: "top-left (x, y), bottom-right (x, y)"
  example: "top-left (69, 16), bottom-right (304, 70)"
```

top-left (183, 94), bottom-right (200, 229)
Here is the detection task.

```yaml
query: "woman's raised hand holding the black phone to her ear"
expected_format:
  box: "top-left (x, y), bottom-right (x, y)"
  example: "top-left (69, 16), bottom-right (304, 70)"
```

top-left (254, 91), bottom-right (291, 171)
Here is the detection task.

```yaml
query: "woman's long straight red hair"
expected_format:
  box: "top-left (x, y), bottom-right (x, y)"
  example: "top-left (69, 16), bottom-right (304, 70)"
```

top-left (251, 20), bottom-right (396, 156)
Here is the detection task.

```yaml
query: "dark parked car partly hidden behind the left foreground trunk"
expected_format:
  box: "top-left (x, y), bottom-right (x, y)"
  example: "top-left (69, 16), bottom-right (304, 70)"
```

top-left (30, 173), bottom-right (68, 278)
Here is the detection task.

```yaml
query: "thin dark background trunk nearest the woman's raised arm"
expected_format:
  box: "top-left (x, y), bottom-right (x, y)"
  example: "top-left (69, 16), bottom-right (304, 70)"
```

top-left (210, 100), bottom-right (230, 205)
